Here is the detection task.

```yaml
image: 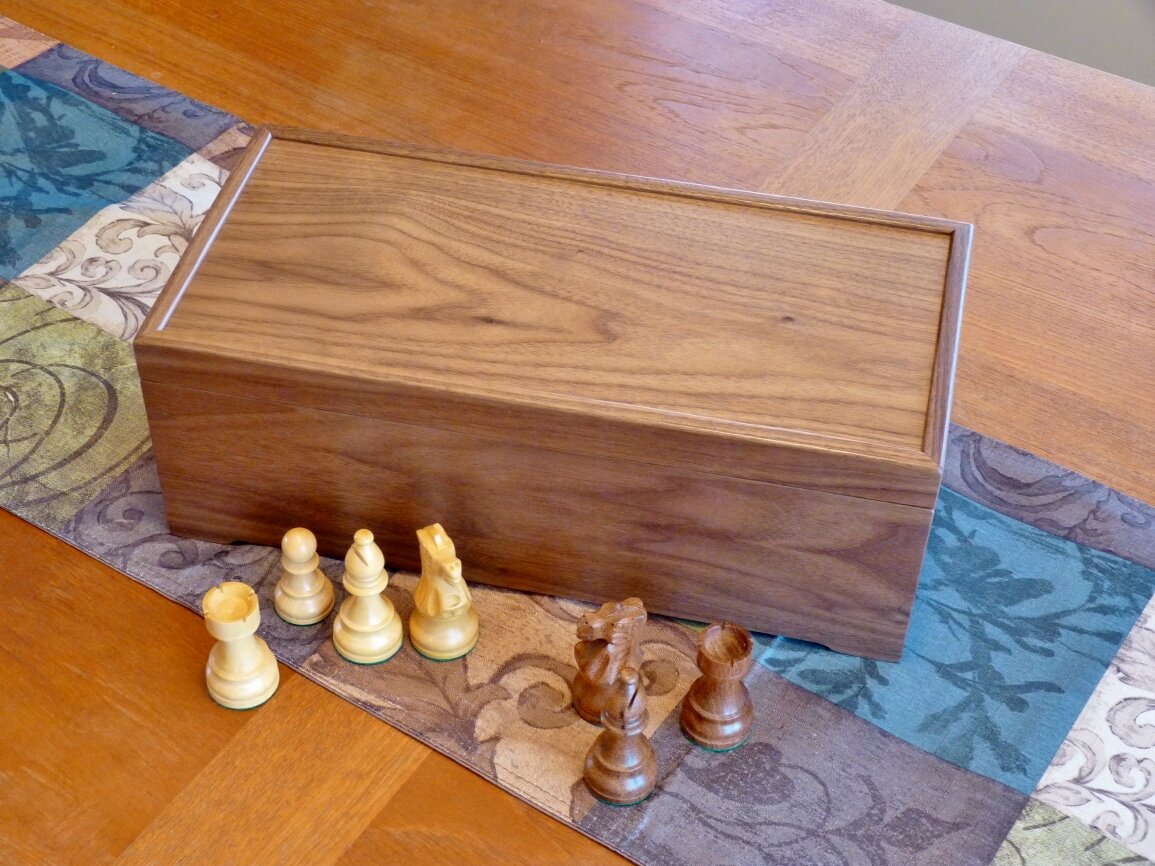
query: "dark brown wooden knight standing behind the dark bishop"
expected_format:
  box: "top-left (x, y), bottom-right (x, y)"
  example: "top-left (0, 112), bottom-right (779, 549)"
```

top-left (569, 598), bottom-right (646, 725)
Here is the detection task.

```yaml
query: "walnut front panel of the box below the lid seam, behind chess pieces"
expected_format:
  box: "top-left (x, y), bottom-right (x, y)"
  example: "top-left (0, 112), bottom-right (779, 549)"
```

top-left (144, 382), bottom-right (931, 658)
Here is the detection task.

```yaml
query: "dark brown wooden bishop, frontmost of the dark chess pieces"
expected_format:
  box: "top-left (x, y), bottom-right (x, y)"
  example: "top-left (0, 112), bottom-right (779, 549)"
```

top-left (582, 667), bottom-right (657, 806)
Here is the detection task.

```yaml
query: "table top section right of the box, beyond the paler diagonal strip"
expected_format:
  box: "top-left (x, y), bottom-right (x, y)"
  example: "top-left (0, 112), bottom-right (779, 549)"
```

top-left (902, 53), bottom-right (1155, 501)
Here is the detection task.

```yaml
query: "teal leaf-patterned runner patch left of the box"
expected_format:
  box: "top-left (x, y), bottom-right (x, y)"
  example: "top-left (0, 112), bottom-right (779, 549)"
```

top-left (0, 69), bottom-right (192, 279)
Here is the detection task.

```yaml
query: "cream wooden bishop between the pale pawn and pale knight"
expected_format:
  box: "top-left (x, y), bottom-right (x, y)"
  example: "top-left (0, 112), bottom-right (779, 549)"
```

top-left (333, 529), bottom-right (404, 665)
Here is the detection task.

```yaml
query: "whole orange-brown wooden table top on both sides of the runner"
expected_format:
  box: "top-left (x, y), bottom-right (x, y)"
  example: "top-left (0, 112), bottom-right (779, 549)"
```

top-left (0, 0), bottom-right (1155, 864)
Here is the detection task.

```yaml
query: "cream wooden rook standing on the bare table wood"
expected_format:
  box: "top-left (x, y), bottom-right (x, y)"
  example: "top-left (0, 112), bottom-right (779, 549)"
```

top-left (201, 581), bottom-right (281, 710)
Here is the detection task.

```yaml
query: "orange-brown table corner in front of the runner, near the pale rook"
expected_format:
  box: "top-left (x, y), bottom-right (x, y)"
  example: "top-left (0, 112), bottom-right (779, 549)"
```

top-left (0, 510), bottom-right (620, 866)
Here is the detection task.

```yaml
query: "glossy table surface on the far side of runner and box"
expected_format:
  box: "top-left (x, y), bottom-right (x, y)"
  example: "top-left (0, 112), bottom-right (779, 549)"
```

top-left (5, 0), bottom-right (1155, 501)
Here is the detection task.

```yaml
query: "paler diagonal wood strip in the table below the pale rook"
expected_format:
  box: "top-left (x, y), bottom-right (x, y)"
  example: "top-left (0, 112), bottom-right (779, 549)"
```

top-left (117, 677), bottom-right (425, 866)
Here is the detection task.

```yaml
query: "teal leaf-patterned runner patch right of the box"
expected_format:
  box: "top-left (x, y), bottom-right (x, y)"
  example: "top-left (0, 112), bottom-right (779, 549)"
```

top-left (760, 490), bottom-right (1155, 793)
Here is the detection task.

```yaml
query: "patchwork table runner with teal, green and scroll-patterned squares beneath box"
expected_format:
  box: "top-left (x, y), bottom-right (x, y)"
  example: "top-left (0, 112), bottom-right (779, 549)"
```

top-left (0, 20), bottom-right (1155, 865)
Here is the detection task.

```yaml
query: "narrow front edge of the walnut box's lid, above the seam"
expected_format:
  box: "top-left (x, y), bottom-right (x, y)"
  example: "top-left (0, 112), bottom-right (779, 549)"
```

top-left (135, 341), bottom-right (941, 509)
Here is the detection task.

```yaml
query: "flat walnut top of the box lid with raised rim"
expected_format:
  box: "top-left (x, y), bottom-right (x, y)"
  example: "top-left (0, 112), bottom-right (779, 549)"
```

top-left (141, 132), bottom-right (961, 505)
